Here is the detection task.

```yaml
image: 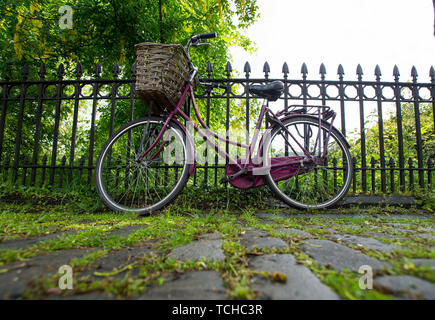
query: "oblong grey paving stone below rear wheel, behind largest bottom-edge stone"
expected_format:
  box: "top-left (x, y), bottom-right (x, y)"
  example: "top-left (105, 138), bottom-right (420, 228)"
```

top-left (302, 240), bottom-right (390, 271)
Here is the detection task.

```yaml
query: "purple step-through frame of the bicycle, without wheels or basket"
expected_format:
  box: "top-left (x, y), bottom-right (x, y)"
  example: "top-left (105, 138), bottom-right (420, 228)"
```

top-left (136, 84), bottom-right (335, 175)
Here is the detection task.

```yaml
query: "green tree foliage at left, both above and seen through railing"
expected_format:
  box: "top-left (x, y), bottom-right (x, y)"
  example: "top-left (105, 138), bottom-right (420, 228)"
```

top-left (0, 0), bottom-right (258, 175)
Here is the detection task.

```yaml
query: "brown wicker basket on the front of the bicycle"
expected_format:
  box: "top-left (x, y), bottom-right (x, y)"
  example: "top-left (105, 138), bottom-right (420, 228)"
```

top-left (134, 42), bottom-right (196, 114)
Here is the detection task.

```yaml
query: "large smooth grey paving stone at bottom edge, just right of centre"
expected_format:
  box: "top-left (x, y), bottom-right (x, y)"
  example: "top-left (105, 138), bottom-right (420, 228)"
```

top-left (249, 254), bottom-right (339, 300)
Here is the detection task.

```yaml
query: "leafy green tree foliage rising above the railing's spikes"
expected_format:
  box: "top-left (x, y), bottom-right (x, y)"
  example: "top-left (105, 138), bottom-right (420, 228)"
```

top-left (0, 0), bottom-right (258, 78)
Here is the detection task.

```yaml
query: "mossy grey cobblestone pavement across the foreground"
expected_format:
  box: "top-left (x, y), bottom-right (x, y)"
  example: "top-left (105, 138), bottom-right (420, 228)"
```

top-left (0, 212), bottom-right (435, 300)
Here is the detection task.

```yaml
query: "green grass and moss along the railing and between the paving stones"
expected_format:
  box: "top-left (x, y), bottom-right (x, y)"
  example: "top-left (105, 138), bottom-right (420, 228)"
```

top-left (0, 186), bottom-right (435, 299)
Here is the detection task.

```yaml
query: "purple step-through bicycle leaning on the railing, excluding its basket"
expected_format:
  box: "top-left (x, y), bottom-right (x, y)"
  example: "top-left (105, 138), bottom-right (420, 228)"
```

top-left (95, 33), bottom-right (353, 215)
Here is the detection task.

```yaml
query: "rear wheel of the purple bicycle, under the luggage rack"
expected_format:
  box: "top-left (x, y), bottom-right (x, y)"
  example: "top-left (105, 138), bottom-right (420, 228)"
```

top-left (263, 116), bottom-right (353, 209)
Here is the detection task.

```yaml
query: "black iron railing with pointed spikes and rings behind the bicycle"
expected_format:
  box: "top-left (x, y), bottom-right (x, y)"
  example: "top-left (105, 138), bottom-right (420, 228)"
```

top-left (0, 63), bottom-right (435, 193)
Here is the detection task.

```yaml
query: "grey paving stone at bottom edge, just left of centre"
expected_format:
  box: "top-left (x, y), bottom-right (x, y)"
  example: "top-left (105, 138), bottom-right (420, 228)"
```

top-left (139, 271), bottom-right (227, 300)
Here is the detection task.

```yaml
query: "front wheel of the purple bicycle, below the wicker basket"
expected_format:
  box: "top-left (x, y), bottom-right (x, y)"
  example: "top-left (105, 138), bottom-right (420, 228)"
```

top-left (95, 117), bottom-right (191, 215)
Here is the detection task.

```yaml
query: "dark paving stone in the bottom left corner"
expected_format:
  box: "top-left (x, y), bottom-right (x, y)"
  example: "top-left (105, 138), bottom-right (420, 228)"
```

top-left (0, 249), bottom-right (93, 299)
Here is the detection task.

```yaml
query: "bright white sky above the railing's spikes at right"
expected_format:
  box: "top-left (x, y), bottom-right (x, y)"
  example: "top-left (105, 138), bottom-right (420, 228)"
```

top-left (231, 0), bottom-right (435, 82)
